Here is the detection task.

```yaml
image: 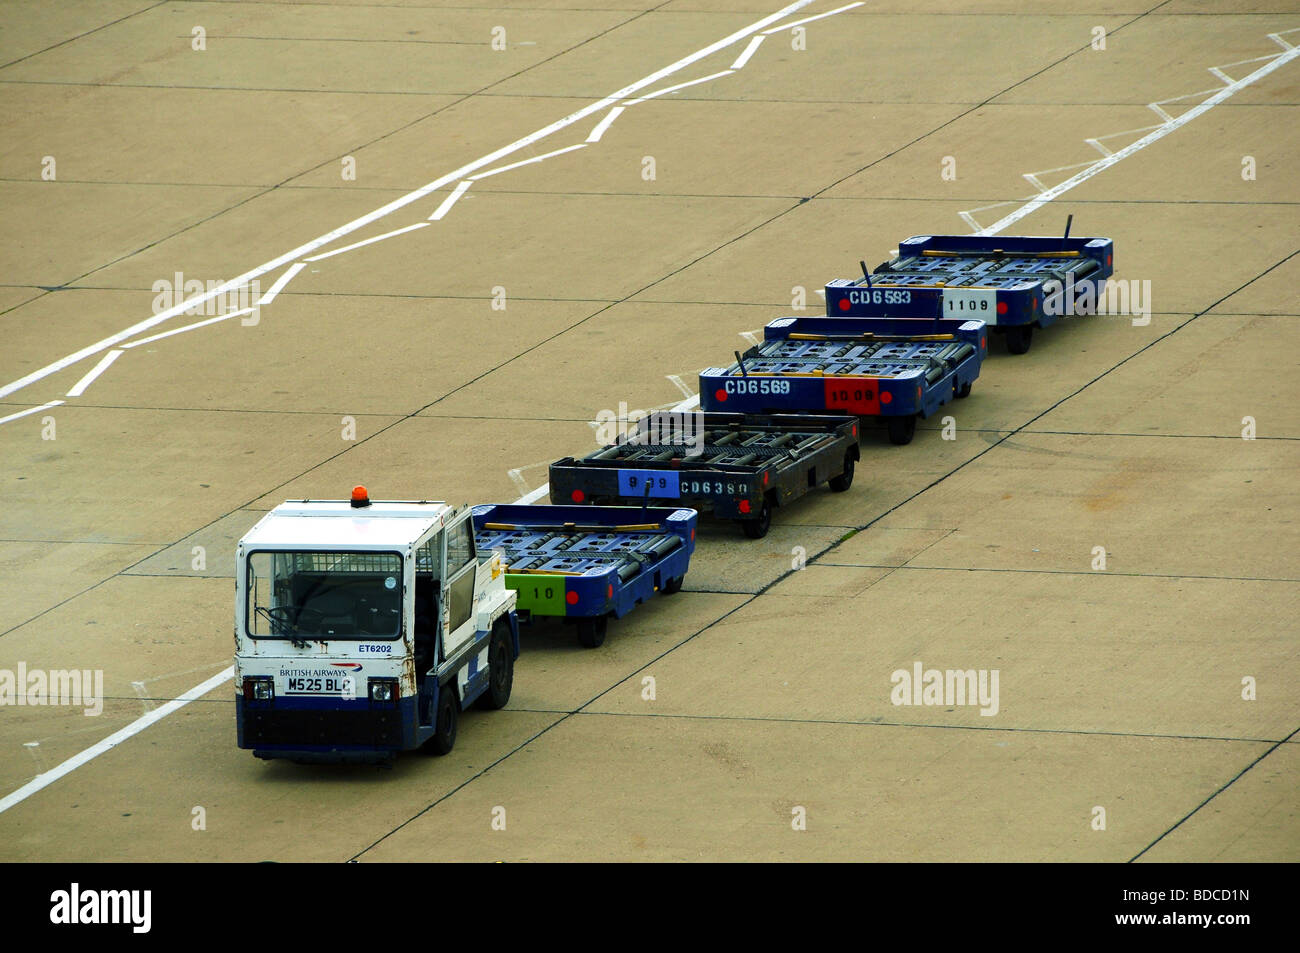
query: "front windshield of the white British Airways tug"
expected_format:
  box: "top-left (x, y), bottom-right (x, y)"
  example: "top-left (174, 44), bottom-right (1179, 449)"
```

top-left (247, 553), bottom-right (402, 641)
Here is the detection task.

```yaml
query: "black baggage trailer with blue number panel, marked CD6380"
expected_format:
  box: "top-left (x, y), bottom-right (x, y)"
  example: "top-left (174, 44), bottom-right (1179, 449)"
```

top-left (550, 412), bottom-right (859, 540)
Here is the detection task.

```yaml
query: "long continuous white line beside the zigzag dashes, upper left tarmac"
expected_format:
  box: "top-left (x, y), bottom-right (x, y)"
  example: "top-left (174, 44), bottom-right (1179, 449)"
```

top-left (0, 0), bottom-right (813, 399)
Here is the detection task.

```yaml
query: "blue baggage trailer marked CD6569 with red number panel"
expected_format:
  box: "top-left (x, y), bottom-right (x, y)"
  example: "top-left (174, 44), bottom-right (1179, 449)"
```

top-left (699, 317), bottom-right (988, 443)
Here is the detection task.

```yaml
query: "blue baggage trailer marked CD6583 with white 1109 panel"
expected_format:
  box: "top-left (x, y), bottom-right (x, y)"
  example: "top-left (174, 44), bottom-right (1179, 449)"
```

top-left (826, 225), bottom-right (1114, 354)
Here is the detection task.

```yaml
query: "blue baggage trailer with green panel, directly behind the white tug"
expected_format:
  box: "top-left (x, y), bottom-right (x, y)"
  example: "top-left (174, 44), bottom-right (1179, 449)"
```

top-left (472, 503), bottom-right (697, 649)
